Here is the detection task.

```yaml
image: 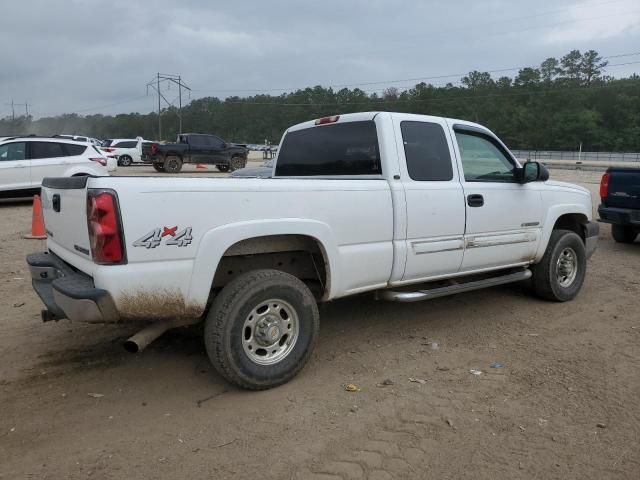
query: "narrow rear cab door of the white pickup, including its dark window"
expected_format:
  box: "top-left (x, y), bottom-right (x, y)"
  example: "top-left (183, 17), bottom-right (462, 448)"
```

top-left (394, 115), bottom-right (465, 282)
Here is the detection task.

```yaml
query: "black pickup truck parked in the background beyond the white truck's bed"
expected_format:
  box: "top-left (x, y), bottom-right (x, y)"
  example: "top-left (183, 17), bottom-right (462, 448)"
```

top-left (142, 133), bottom-right (249, 173)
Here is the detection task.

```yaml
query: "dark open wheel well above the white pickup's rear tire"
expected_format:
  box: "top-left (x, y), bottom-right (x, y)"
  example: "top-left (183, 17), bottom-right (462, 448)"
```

top-left (212, 235), bottom-right (329, 300)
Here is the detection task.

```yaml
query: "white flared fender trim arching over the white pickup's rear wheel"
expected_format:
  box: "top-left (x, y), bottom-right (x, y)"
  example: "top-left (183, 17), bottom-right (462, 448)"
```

top-left (189, 218), bottom-right (338, 305)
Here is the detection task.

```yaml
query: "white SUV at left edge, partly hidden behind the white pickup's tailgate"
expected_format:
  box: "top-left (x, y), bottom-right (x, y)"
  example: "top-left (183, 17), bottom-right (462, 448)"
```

top-left (0, 137), bottom-right (109, 197)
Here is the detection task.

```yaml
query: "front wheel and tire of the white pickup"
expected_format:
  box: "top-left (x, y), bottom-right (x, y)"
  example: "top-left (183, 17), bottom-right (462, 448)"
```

top-left (531, 230), bottom-right (587, 302)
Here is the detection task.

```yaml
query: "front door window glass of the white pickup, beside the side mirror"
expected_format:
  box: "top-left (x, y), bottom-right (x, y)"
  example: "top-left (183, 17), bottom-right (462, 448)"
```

top-left (456, 131), bottom-right (517, 182)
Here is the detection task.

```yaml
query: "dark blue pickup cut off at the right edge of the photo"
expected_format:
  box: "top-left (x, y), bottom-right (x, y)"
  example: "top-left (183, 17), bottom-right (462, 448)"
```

top-left (598, 167), bottom-right (640, 243)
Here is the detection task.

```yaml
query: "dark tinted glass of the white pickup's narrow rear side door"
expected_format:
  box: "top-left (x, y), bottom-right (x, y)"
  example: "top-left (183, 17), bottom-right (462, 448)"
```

top-left (400, 122), bottom-right (453, 181)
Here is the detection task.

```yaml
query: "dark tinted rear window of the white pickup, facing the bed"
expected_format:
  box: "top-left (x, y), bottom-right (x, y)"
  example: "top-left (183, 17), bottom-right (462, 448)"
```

top-left (276, 121), bottom-right (382, 176)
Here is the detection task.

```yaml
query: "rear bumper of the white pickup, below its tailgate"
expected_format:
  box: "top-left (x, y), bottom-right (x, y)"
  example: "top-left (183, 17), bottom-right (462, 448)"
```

top-left (27, 252), bottom-right (119, 323)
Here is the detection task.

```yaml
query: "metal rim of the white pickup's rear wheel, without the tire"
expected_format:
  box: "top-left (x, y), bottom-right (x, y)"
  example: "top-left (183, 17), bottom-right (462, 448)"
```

top-left (241, 298), bottom-right (300, 365)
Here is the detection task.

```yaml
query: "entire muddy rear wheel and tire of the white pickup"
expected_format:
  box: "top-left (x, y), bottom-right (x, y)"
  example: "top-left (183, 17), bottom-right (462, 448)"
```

top-left (204, 270), bottom-right (320, 390)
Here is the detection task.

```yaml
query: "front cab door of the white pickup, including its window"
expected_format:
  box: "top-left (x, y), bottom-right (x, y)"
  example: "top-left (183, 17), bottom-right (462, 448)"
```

top-left (453, 125), bottom-right (543, 271)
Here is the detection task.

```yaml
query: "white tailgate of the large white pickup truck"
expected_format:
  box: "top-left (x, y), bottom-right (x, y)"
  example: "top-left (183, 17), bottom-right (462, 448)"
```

top-left (41, 176), bottom-right (91, 268)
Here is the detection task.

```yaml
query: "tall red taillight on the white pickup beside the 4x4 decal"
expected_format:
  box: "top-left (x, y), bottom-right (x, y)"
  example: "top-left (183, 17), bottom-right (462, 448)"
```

top-left (87, 190), bottom-right (125, 265)
